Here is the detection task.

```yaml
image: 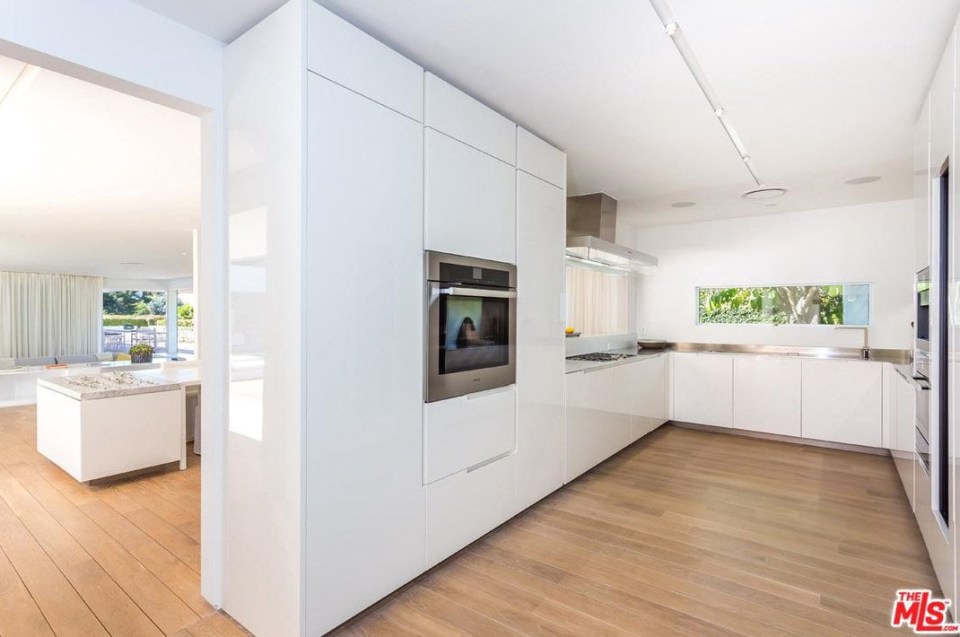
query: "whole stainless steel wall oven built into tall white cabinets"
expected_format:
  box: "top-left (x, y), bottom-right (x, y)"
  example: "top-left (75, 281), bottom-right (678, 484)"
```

top-left (425, 251), bottom-right (517, 403)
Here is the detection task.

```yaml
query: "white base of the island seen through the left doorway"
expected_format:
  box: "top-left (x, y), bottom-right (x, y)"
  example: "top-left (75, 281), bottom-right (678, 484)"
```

top-left (37, 383), bottom-right (183, 482)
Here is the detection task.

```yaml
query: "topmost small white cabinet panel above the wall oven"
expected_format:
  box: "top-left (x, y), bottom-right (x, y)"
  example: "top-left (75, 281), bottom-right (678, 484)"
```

top-left (424, 73), bottom-right (517, 166)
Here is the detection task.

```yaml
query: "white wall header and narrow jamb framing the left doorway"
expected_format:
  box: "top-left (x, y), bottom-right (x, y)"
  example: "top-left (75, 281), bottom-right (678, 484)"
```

top-left (0, 0), bottom-right (227, 605)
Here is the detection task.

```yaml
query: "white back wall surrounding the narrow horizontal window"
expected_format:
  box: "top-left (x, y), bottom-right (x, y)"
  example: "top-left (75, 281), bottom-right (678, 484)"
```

top-left (634, 200), bottom-right (916, 349)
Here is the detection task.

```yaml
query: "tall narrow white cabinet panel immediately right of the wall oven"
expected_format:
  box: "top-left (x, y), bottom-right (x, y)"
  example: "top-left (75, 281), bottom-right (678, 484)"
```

top-left (516, 170), bottom-right (566, 510)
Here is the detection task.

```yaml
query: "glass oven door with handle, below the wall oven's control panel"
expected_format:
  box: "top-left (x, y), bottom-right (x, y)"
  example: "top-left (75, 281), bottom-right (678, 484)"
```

top-left (426, 282), bottom-right (517, 402)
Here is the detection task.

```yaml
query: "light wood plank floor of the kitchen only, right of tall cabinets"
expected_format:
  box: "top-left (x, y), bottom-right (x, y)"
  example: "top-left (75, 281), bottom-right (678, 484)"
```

top-left (335, 426), bottom-right (939, 637)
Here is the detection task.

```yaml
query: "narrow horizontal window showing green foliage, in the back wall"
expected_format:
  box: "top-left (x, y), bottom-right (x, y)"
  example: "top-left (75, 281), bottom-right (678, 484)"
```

top-left (697, 283), bottom-right (870, 325)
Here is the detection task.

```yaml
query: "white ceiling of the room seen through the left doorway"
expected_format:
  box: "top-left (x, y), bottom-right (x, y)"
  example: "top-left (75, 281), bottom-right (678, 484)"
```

top-left (0, 57), bottom-right (200, 279)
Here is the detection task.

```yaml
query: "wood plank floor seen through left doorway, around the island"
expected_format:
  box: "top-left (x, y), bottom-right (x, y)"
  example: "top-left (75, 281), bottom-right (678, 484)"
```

top-left (0, 407), bottom-right (248, 637)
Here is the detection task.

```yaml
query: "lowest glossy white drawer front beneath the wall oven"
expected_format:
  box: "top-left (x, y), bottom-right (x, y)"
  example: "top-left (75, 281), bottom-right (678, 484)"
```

top-left (426, 454), bottom-right (516, 568)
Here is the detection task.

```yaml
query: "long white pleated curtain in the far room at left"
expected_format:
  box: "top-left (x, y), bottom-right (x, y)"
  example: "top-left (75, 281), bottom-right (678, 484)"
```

top-left (0, 271), bottom-right (103, 358)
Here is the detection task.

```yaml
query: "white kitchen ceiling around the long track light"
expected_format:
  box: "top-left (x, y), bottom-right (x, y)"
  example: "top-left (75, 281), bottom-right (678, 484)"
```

top-left (129, 0), bottom-right (960, 225)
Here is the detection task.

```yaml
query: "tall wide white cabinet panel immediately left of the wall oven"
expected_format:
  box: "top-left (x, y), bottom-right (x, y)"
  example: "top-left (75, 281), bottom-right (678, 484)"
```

top-left (304, 75), bottom-right (426, 634)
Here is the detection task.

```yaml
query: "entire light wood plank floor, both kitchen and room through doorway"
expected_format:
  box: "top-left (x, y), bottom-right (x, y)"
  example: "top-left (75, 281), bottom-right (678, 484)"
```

top-left (0, 408), bottom-right (938, 637)
